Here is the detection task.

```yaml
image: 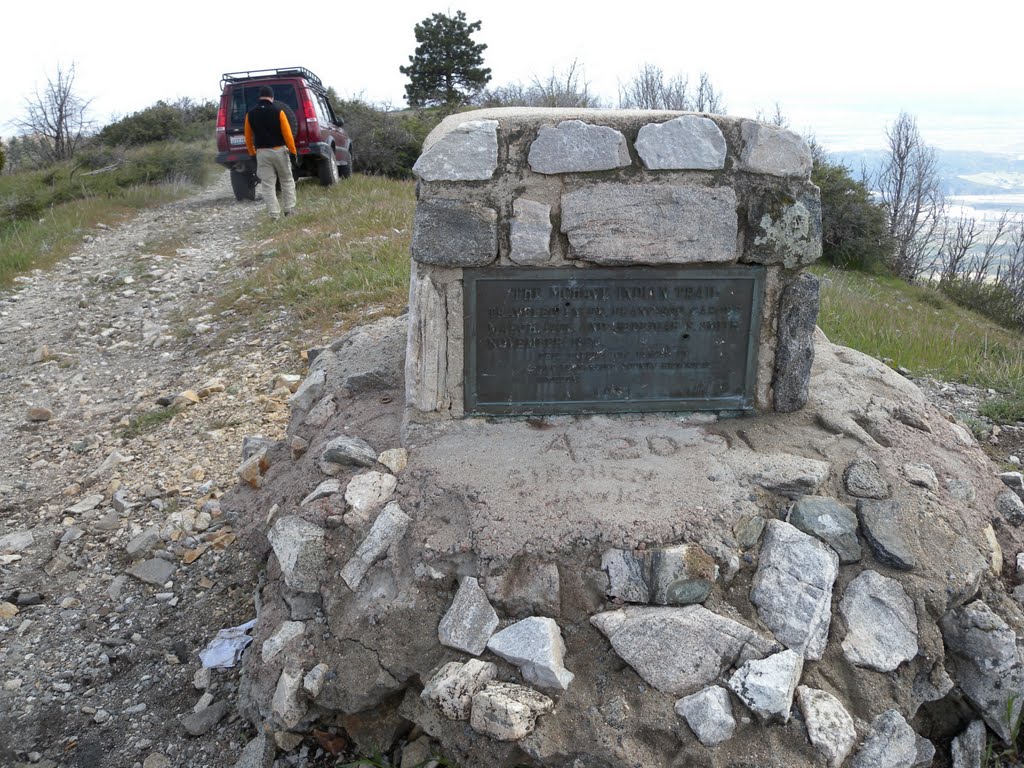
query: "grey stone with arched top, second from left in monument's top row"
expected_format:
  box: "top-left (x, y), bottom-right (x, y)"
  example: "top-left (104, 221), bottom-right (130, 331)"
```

top-left (527, 120), bottom-right (632, 174)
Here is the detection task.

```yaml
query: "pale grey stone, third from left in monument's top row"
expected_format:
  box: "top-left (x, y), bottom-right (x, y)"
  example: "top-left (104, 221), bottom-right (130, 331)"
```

top-left (636, 115), bottom-right (726, 171)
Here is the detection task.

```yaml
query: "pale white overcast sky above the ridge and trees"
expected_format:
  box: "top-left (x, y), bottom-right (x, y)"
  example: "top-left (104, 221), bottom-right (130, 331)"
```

top-left (0, 0), bottom-right (1024, 155)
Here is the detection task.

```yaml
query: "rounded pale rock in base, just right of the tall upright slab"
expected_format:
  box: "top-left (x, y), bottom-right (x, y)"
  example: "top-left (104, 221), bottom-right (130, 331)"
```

top-left (839, 570), bottom-right (918, 672)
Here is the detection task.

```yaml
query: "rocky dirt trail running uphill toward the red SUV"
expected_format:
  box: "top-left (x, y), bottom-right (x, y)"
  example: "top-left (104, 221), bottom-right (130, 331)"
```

top-left (0, 175), bottom-right (302, 768)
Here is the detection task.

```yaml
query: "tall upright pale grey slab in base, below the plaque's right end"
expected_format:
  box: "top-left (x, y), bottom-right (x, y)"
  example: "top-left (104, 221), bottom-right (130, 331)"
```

top-left (751, 520), bottom-right (839, 659)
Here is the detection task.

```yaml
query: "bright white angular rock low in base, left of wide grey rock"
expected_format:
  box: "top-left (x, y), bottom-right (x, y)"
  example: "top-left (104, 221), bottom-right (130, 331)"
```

top-left (487, 616), bottom-right (574, 690)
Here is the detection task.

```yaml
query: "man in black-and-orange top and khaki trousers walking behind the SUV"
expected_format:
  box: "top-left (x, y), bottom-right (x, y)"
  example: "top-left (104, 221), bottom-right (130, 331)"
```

top-left (246, 85), bottom-right (298, 219)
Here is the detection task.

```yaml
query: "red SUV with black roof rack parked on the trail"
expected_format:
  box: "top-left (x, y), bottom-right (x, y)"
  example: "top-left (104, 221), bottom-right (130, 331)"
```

top-left (217, 67), bottom-right (352, 200)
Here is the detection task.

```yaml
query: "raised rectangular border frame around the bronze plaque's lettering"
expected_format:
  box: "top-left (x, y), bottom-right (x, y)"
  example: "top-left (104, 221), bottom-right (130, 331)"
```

top-left (462, 264), bottom-right (766, 416)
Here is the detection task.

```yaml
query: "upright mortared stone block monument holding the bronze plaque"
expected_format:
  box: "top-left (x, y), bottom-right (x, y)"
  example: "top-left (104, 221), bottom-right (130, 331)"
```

top-left (407, 109), bottom-right (821, 421)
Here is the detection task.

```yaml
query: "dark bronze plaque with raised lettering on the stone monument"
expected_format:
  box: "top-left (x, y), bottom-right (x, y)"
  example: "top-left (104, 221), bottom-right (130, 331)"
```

top-left (464, 266), bottom-right (764, 415)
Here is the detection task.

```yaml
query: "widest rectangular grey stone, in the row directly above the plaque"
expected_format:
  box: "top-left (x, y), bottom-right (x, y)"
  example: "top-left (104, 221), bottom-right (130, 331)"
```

top-left (561, 183), bottom-right (738, 265)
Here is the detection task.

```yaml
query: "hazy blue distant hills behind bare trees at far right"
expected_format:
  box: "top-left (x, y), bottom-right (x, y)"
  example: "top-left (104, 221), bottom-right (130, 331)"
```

top-left (835, 150), bottom-right (1024, 196)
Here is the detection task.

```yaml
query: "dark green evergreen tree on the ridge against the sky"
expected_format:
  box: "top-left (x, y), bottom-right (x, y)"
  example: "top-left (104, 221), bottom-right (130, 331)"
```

top-left (398, 10), bottom-right (490, 106)
